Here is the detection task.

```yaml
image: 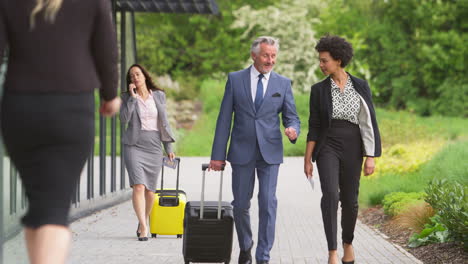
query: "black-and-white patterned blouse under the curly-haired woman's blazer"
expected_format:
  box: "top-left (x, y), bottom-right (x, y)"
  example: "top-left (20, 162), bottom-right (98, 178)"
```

top-left (330, 76), bottom-right (361, 125)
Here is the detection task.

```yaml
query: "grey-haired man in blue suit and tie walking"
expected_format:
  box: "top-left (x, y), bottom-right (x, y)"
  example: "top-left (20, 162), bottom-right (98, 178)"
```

top-left (210, 37), bottom-right (300, 264)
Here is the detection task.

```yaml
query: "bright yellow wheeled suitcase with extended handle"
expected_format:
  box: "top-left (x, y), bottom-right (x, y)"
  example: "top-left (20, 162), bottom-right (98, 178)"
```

top-left (149, 158), bottom-right (187, 238)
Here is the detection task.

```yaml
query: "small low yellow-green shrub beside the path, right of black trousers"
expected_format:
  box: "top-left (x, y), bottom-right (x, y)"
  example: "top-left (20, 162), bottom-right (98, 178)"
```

top-left (383, 192), bottom-right (425, 216)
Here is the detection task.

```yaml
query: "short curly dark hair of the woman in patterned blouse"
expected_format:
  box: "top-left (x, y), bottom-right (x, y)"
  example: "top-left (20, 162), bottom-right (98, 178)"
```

top-left (315, 35), bottom-right (353, 68)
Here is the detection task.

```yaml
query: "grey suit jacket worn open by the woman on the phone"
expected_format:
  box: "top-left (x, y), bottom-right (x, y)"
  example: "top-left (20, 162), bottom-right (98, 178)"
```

top-left (120, 91), bottom-right (175, 153)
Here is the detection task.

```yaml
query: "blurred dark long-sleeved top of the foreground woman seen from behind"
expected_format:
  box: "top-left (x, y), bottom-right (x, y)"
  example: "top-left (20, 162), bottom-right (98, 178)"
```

top-left (0, 0), bottom-right (119, 101)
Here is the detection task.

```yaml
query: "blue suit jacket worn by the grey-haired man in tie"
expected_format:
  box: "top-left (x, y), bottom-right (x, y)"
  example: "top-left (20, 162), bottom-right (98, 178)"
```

top-left (211, 66), bottom-right (300, 165)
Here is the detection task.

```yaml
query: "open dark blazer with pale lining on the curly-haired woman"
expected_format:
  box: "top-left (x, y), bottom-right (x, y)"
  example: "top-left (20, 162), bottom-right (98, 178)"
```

top-left (307, 73), bottom-right (382, 161)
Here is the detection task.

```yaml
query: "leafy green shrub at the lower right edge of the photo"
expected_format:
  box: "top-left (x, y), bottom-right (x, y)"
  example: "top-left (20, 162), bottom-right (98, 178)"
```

top-left (425, 179), bottom-right (468, 247)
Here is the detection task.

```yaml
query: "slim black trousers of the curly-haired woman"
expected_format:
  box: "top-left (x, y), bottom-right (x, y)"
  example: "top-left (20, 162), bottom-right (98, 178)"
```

top-left (317, 119), bottom-right (363, 250)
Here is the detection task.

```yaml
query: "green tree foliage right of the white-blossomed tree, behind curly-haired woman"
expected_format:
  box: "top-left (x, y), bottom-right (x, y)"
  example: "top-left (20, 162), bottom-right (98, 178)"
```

top-left (320, 0), bottom-right (468, 116)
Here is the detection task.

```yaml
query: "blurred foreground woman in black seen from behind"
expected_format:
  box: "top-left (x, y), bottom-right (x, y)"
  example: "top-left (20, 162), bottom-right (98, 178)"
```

top-left (0, 0), bottom-right (120, 264)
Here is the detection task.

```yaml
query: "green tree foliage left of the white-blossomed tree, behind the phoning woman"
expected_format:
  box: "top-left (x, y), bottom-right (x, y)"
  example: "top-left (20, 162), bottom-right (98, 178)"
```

top-left (136, 0), bottom-right (275, 79)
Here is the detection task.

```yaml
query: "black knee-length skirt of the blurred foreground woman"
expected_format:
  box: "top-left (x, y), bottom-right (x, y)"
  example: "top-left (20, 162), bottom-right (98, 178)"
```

top-left (1, 92), bottom-right (94, 228)
